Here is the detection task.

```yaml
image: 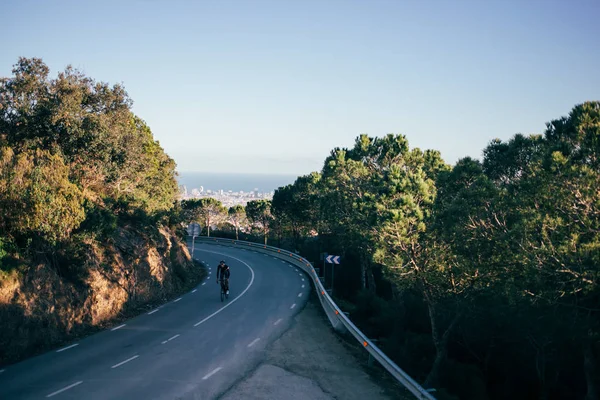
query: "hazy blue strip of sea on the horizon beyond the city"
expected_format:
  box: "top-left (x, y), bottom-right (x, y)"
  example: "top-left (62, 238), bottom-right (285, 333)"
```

top-left (177, 172), bottom-right (298, 193)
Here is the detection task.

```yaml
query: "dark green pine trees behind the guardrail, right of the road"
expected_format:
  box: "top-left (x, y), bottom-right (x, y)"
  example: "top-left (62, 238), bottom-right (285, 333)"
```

top-left (203, 102), bottom-right (600, 400)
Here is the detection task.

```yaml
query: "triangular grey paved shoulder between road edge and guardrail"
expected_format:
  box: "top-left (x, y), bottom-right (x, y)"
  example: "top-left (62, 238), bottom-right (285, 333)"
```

top-left (220, 293), bottom-right (406, 400)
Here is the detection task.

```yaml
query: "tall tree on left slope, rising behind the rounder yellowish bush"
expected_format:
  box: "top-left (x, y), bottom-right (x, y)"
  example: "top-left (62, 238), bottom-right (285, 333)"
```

top-left (0, 58), bottom-right (177, 214)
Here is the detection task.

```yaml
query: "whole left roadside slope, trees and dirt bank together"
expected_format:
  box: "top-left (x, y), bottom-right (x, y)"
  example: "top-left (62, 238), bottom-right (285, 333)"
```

top-left (0, 58), bottom-right (201, 365)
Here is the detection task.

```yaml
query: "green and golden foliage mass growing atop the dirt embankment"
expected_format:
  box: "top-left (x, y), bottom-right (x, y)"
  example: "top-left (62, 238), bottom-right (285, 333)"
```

top-left (0, 58), bottom-right (177, 264)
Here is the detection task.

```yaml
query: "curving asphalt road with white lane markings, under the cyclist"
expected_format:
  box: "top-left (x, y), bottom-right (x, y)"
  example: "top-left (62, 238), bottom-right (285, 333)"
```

top-left (0, 244), bottom-right (311, 400)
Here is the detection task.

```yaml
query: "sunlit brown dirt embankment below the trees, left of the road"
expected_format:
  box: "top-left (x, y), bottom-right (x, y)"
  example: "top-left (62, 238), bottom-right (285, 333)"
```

top-left (0, 228), bottom-right (205, 366)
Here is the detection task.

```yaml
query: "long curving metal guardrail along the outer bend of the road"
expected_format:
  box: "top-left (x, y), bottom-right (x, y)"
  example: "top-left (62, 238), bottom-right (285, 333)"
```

top-left (196, 237), bottom-right (435, 400)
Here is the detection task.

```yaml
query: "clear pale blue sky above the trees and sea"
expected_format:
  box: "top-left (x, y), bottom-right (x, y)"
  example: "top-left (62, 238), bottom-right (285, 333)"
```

top-left (0, 0), bottom-right (600, 174)
